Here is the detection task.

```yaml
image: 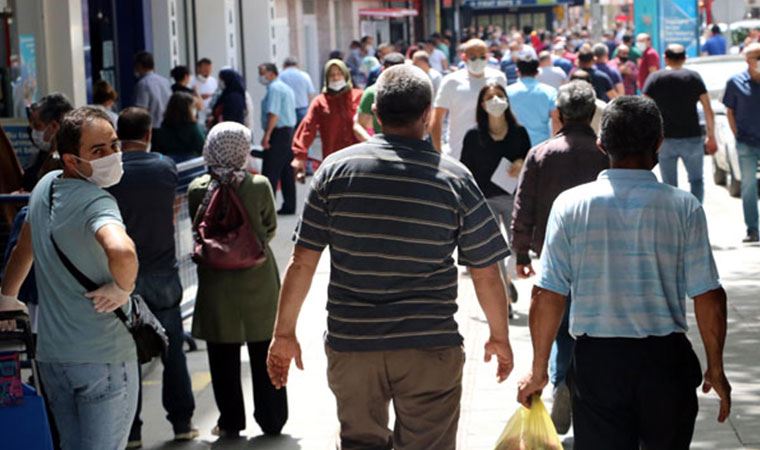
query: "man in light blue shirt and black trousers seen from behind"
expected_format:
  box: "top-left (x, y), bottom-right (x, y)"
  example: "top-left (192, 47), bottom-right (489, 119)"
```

top-left (518, 97), bottom-right (731, 450)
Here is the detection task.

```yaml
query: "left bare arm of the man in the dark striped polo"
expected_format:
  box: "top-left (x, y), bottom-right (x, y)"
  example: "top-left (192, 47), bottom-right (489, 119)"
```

top-left (267, 245), bottom-right (322, 389)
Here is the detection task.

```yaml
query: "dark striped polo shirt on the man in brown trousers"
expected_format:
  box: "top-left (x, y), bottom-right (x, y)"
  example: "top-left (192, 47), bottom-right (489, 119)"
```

top-left (295, 135), bottom-right (509, 351)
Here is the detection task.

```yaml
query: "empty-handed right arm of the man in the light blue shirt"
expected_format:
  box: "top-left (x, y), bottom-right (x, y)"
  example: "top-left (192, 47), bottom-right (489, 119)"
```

top-left (694, 288), bottom-right (731, 422)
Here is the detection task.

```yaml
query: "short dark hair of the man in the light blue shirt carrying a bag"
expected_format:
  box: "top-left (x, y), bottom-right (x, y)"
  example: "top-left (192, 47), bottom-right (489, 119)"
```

top-left (599, 95), bottom-right (663, 159)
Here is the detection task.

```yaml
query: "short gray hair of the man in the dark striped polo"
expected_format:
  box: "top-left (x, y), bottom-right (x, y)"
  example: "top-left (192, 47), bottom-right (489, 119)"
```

top-left (375, 64), bottom-right (433, 127)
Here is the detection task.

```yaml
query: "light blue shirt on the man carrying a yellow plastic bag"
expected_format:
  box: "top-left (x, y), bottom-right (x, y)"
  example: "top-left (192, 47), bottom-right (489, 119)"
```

top-left (536, 169), bottom-right (720, 338)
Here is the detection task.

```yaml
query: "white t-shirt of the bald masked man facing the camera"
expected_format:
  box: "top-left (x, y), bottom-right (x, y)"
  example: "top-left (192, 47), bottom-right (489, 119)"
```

top-left (434, 67), bottom-right (507, 161)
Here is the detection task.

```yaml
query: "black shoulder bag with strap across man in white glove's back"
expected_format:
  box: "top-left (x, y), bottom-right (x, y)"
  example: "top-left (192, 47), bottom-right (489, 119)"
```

top-left (49, 180), bottom-right (169, 364)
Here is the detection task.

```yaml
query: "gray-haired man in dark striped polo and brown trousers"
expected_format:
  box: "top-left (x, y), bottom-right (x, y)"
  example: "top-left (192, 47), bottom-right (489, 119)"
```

top-left (268, 65), bottom-right (512, 450)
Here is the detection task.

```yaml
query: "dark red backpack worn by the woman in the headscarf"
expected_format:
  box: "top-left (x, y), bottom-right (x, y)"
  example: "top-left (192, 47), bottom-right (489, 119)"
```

top-left (192, 181), bottom-right (267, 270)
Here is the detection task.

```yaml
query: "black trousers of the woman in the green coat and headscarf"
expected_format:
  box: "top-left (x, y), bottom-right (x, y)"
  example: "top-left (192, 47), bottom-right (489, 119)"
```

top-left (206, 341), bottom-right (288, 434)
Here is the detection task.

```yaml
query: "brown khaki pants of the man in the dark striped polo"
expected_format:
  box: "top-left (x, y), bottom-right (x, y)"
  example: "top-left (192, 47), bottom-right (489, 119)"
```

top-left (325, 346), bottom-right (465, 450)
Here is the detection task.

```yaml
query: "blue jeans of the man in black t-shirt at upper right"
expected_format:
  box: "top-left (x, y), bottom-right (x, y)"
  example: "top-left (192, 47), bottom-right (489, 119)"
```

top-left (659, 136), bottom-right (705, 203)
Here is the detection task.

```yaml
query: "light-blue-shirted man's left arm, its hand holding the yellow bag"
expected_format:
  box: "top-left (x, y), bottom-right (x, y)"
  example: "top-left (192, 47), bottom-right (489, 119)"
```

top-left (517, 286), bottom-right (567, 407)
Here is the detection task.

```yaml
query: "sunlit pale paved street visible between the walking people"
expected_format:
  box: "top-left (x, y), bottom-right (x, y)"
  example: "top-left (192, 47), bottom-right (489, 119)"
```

top-left (138, 159), bottom-right (760, 450)
